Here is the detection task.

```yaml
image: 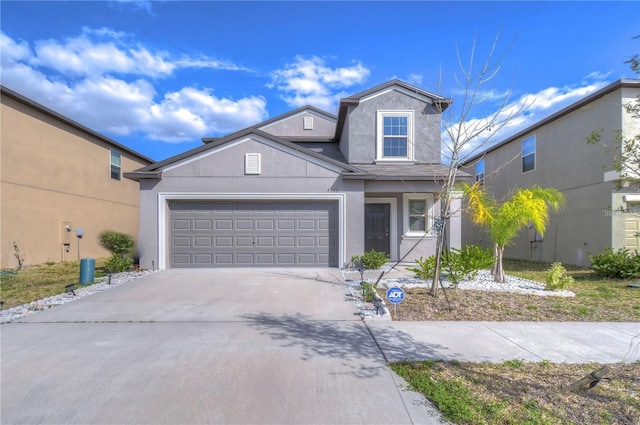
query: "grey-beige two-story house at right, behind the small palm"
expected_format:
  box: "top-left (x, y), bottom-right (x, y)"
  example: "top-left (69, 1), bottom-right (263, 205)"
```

top-left (463, 79), bottom-right (640, 267)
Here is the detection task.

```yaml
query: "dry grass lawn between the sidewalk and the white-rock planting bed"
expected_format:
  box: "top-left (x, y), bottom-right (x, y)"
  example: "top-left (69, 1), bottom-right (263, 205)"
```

top-left (379, 260), bottom-right (640, 322)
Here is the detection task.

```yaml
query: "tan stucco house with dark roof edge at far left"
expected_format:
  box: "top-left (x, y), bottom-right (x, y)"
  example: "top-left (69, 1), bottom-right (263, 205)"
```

top-left (0, 87), bottom-right (153, 269)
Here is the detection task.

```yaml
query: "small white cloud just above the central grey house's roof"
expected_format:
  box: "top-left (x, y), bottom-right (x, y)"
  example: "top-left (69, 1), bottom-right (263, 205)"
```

top-left (268, 56), bottom-right (370, 111)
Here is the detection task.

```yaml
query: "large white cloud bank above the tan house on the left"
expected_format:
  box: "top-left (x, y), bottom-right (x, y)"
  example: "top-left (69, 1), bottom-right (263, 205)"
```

top-left (0, 28), bottom-right (267, 142)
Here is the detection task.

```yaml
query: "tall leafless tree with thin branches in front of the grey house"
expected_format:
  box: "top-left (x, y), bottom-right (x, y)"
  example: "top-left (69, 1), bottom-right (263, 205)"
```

top-left (431, 34), bottom-right (530, 296)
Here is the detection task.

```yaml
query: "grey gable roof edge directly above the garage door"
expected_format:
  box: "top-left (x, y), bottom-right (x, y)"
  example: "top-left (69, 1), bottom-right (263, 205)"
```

top-left (125, 127), bottom-right (360, 180)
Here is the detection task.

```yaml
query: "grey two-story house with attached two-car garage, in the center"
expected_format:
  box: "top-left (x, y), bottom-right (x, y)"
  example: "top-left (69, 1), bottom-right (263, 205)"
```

top-left (126, 80), bottom-right (468, 269)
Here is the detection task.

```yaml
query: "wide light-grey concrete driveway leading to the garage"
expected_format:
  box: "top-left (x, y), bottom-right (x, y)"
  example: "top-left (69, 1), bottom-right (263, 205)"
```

top-left (0, 269), bottom-right (437, 424)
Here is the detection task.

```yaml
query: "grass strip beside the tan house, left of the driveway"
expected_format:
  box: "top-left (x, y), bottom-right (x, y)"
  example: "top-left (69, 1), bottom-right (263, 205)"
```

top-left (0, 259), bottom-right (105, 309)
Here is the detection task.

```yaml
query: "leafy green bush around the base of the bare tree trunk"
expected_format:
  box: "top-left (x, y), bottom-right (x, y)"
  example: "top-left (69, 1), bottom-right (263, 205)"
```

top-left (407, 245), bottom-right (494, 284)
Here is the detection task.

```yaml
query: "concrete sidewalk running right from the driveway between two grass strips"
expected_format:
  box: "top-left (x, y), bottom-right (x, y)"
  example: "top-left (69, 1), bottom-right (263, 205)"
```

top-left (366, 320), bottom-right (640, 363)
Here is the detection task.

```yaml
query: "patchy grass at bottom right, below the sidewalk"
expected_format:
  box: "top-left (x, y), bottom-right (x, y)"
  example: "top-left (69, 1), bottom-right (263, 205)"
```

top-left (391, 360), bottom-right (640, 425)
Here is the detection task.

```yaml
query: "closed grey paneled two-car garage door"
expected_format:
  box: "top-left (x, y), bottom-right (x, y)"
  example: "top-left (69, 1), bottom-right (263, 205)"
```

top-left (168, 200), bottom-right (338, 268)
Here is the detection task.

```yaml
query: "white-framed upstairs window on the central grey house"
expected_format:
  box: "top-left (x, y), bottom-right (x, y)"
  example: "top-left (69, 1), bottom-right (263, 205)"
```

top-left (377, 111), bottom-right (413, 160)
